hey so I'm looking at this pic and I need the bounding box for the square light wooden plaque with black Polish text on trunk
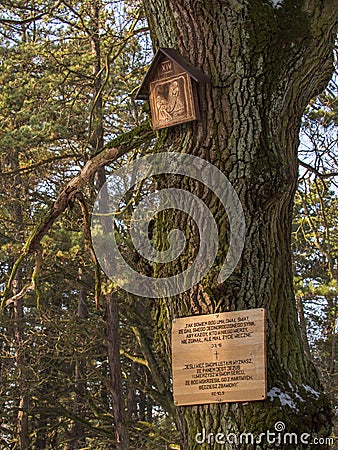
[172,309,266,406]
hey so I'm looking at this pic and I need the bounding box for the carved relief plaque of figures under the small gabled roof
[150,73,198,130]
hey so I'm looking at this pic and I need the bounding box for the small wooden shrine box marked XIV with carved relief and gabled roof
[135,48,211,130]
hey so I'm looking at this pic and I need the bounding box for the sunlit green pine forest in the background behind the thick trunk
[0,0,338,450]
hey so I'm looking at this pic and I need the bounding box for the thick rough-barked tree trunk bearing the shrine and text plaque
[145,0,335,449]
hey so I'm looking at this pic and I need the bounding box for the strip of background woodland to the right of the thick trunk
[293,73,338,434]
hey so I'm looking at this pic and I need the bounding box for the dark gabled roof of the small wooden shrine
[135,47,211,100]
